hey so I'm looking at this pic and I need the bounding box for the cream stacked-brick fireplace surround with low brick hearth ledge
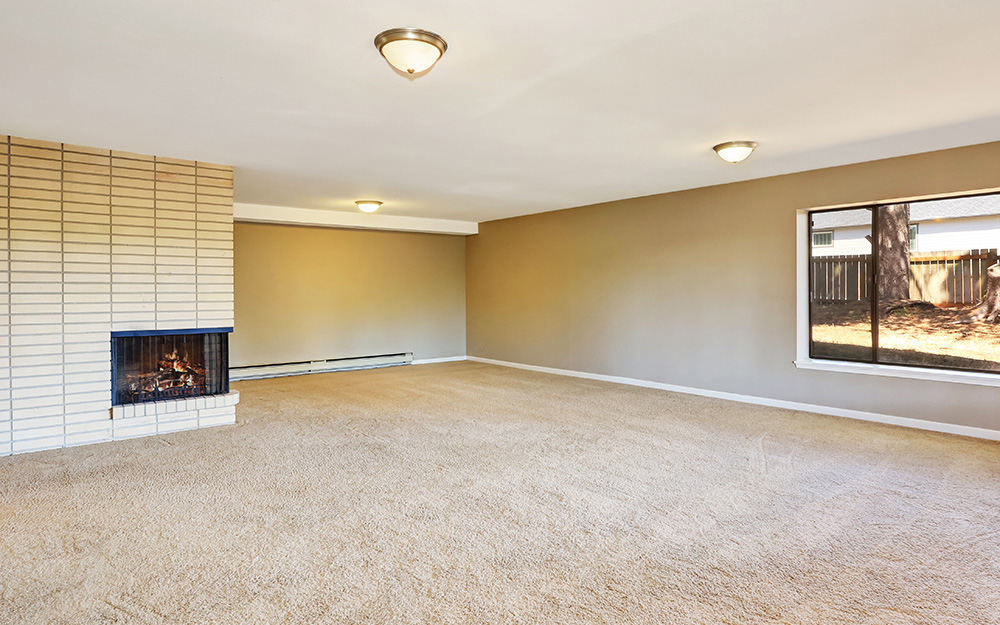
[0,135,239,455]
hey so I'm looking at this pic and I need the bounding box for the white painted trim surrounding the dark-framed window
[794,187,1000,387]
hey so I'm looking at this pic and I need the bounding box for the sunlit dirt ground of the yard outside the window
[812,303,1000,371]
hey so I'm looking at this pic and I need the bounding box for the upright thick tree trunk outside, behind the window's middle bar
[876,204,910,306]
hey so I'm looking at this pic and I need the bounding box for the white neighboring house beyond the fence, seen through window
[812,195,1000,256]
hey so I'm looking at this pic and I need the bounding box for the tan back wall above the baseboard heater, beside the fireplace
[231,223,465,366]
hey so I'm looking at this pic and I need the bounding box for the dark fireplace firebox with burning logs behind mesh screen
[111,328,233,406]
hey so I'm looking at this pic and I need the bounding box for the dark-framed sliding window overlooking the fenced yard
[806,194,1000,373]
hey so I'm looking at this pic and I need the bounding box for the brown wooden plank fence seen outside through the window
[812,249,998,307]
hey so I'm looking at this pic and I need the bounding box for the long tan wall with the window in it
[466,143,1000,429]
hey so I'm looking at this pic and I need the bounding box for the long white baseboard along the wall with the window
[467,356,1000,441]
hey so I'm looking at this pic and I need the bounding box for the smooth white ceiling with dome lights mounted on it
[0,0,1000,221]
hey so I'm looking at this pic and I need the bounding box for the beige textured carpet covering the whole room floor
[0,363,1000,625]
